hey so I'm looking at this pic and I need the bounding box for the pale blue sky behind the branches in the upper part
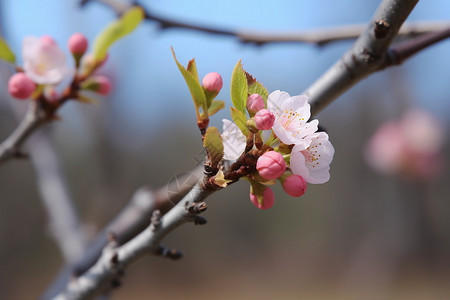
[0,0,450,134]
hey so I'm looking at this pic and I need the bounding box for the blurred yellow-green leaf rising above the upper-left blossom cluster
[93,6,144,62]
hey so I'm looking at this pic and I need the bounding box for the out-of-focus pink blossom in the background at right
[364,109,445,180]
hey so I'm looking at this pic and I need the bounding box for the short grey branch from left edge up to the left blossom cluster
[0,101,49,165]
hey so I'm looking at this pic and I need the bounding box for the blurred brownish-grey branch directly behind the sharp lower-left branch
[42,165,203,299]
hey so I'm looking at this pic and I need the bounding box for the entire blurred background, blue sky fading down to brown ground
[0,0,450,299]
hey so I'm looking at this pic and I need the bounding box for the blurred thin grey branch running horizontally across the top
[80,0,450,46]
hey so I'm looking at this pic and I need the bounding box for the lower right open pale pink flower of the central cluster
[290,132,334,184]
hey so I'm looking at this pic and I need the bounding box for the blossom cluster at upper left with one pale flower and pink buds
[8,33,111,105]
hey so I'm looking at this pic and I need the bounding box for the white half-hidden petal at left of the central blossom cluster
[222,119,247,160]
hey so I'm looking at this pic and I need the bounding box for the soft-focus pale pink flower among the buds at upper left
[22,36,72,84]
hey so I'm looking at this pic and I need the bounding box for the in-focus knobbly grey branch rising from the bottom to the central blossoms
[54,179,214,300]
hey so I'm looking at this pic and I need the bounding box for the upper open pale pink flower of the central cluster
[267,90,319,148]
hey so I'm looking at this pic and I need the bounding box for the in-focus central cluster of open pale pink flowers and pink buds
[222,90,334,209]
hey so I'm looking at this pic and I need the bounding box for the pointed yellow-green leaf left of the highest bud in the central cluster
[172,48,208,116]
